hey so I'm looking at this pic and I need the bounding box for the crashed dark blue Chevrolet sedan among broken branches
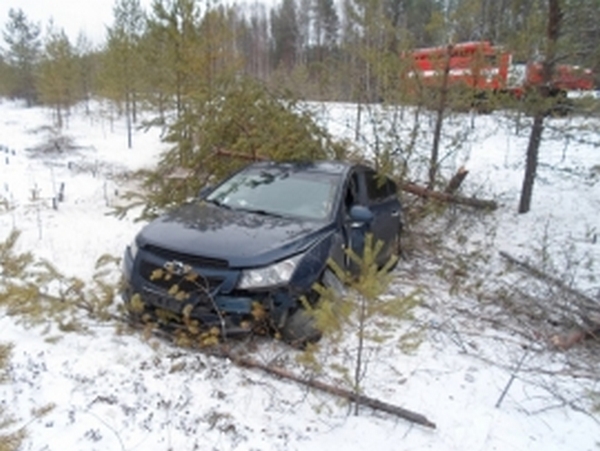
[124,161,402,344]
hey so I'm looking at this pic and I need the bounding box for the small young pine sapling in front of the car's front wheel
[299,234,421,414]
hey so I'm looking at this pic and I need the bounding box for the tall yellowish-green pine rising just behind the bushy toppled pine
[143,0,243,152]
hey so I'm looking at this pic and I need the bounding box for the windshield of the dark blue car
[206,168,337,220]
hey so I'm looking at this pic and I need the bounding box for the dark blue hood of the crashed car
[138,202,334,267]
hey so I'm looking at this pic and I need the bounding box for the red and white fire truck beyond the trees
[404,41,594,97]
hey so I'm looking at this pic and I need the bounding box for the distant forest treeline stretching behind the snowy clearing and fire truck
[0,0,600,121]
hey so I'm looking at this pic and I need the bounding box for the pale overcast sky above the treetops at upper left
[0,0,152,44]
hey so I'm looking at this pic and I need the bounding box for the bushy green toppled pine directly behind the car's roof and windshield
[116,78,343,222]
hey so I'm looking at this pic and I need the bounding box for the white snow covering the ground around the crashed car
[0,100,600,451]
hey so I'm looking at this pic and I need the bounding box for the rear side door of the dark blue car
[363,169,401,265]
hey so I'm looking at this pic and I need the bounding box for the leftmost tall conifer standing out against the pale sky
[3,8,41,106]
